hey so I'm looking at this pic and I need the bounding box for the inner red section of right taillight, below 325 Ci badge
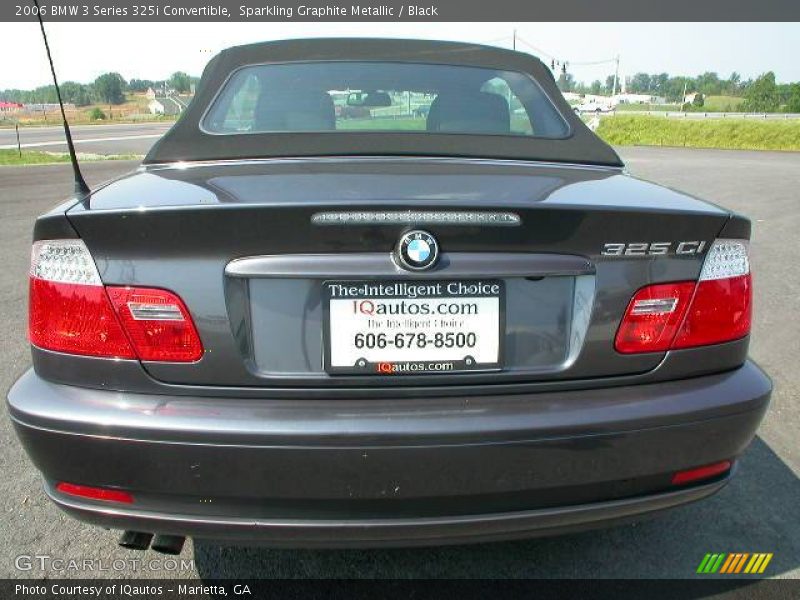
[614,281,695,354]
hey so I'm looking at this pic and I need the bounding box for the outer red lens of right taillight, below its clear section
[672,274,753,348]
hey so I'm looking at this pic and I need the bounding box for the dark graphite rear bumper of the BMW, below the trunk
[8,362,771,546]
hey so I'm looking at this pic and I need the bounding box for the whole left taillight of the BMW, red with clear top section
[28,240,203,362]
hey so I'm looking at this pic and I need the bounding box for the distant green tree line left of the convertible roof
[0,71,198,106]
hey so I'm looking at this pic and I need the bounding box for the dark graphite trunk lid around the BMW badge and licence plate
[68,158,729,387]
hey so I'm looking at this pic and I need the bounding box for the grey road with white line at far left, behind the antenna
[0,122,172,154]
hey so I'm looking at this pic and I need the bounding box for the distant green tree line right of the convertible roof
[558,71,800,113]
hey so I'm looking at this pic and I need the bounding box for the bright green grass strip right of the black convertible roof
[596,115,800,151]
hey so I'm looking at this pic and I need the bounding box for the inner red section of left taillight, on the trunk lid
[106,287,203,362]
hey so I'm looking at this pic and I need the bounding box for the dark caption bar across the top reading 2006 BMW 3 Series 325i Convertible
[0,0,800,22]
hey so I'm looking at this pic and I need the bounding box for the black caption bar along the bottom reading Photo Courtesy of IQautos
[6,579,800,600]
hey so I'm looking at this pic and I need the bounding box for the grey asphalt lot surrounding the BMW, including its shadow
[0,148,800,578]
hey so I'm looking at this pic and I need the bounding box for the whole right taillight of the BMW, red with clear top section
[614,240,753,354]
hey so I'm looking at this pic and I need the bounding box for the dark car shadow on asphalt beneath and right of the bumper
[194,438,800,579]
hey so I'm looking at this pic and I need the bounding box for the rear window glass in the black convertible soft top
[202,61,569,138]
